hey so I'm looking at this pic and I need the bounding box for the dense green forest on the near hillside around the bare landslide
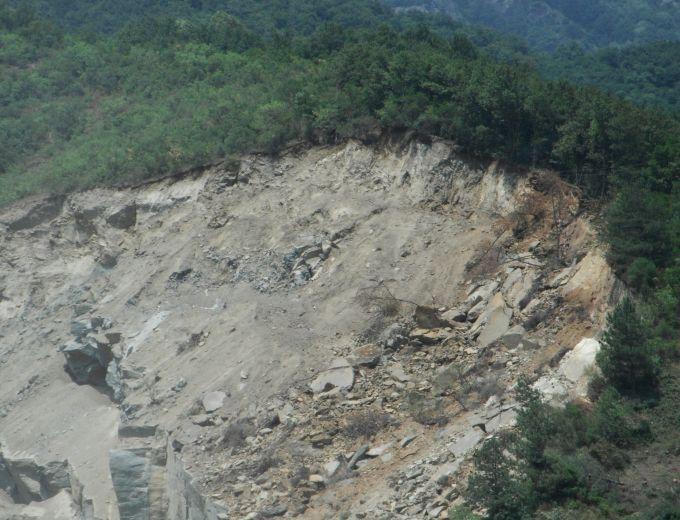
[0,0,680,519]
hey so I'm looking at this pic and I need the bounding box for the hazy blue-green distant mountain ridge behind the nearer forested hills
[388,0,680,50]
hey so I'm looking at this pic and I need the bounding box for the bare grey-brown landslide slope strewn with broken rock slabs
[0,136,617,520]
